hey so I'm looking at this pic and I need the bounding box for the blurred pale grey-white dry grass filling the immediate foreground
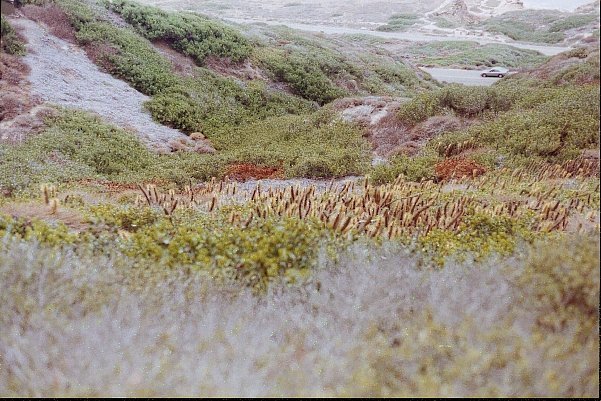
[0,238,599,397]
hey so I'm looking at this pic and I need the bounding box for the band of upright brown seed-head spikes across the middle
[158,164,598,239]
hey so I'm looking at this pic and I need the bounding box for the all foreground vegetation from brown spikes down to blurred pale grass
[0,167,599,396]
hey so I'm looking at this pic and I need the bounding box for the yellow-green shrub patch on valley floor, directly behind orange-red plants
[212,111,369,178]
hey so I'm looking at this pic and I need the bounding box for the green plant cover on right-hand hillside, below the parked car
[372,55,599,181]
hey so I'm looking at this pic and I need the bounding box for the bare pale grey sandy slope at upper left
[11,18,193,152]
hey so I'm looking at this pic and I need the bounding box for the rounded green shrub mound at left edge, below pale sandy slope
[0,111,153,190]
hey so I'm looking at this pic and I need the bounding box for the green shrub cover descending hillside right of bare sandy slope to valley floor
[12,0,432,173]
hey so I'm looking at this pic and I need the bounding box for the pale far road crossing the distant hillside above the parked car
[224,18,571,56]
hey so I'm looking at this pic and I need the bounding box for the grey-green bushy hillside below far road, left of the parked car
[253,27,426,104]
